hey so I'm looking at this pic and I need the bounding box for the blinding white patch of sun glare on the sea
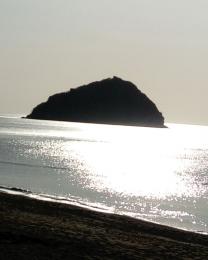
[61,124,205,198]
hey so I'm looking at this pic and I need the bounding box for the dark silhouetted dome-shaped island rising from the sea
[27,77,164,127]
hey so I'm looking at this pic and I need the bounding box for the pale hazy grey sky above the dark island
[0,0,208,125]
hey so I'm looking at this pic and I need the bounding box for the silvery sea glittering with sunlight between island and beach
[0,117,208,233]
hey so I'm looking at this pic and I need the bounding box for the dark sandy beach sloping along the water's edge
[0,192,208,260]
